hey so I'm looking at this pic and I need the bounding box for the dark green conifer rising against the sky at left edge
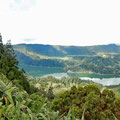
[0,34,30,92]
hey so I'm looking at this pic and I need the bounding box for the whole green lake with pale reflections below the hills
[20,66,120,86]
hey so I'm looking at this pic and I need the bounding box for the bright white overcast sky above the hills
[0,0,120,46]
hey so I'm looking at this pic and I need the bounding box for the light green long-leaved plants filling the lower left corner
[0,74,58,120]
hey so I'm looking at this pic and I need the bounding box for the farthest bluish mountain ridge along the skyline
[14,44,120,57]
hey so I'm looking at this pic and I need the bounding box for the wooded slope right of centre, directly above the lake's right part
[67,55,120,75]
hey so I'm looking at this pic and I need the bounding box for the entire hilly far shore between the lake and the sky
[14,44,120,75]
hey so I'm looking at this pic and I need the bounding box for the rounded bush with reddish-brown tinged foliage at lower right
[52,84,120,120]
